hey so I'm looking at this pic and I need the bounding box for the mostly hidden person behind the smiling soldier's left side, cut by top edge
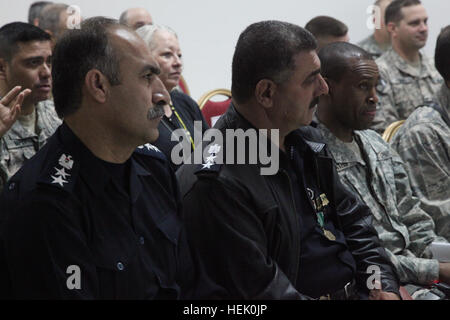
[358,0,392,59]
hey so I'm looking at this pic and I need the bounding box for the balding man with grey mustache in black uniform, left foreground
[0,17,197,299]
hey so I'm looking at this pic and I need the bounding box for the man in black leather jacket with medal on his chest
[178,21,399,299]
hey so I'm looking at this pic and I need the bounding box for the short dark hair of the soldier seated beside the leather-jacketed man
[319,42,373,82]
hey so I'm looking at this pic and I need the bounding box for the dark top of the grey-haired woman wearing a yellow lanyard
[153,90,209,170]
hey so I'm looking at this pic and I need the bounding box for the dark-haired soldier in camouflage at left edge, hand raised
[0,22,61,191]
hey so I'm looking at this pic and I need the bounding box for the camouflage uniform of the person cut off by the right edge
[391,84,450,241]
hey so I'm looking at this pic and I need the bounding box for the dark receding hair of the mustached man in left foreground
[52,17,125,118]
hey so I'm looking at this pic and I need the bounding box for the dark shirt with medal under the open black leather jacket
[281,136,356,298]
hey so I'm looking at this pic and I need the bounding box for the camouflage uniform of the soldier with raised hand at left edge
[0,100,61,191]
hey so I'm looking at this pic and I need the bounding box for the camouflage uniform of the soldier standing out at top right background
[372,49,443,133]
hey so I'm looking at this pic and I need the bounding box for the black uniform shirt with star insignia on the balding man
[0,124,193,299]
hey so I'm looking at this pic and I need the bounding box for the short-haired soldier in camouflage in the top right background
[372,0,442,133]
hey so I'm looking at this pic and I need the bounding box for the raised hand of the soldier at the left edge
[0,86,31,137]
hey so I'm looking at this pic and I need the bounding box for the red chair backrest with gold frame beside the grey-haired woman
[198,89,231,127]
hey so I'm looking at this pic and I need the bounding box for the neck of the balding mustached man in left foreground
[64,108,138,163]
